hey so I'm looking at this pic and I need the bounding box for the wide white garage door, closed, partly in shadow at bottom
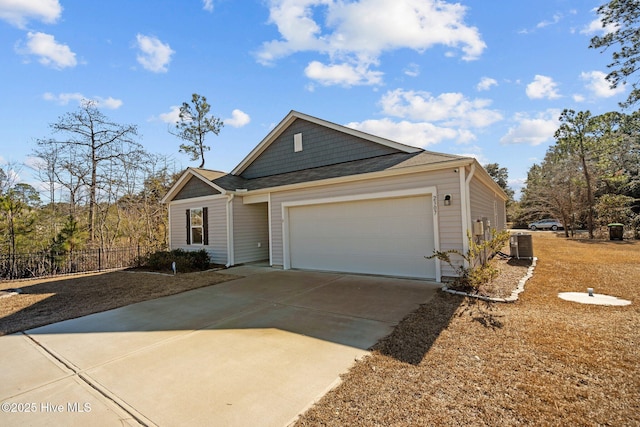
[289,196,436,278]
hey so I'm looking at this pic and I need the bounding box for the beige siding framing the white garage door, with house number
[271,168,462,273]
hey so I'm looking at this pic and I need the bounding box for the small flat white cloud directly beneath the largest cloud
[304,61,383,86]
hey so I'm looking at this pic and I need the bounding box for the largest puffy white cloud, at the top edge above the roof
[257,0,486,84]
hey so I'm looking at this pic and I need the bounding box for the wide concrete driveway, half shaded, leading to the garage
[0,267,438,426]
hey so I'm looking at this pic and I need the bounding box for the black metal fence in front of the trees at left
[0,246,164,280]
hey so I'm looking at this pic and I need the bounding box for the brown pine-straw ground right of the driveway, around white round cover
[297,232,640,426]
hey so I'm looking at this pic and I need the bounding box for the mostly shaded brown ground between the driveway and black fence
[0,271,238,336]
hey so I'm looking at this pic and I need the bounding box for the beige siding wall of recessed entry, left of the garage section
[233,197,269,264]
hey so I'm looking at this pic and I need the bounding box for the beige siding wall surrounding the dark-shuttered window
[169,197,227,264]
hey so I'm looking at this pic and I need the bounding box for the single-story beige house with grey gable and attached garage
[163,111,507,281]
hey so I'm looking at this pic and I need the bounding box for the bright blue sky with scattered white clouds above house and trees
[0,0,628,199]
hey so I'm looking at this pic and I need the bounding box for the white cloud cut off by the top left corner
[0,0,62,28]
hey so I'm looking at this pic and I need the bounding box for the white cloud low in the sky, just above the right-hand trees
[500,109,560,146]
